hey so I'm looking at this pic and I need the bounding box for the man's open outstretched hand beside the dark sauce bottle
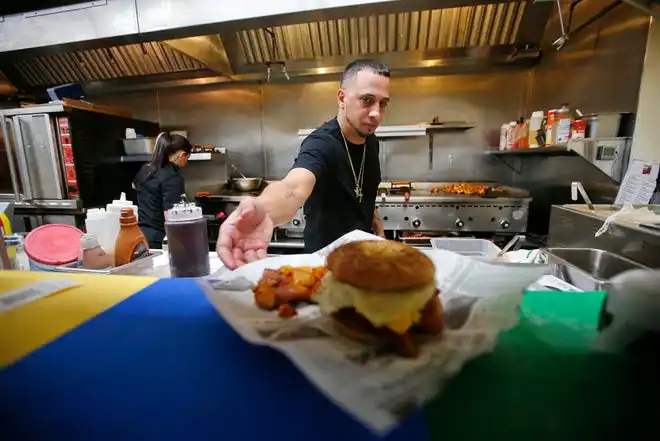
[216,198,274,270]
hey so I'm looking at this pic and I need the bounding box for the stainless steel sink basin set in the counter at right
[545,248,648,291]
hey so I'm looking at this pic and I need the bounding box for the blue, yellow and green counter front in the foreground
[0,271,660,441]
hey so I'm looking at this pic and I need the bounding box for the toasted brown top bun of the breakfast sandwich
[327,240,435,291]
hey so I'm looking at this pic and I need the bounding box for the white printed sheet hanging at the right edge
[615,159,660,205]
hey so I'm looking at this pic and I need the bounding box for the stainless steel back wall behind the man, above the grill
[93,71,527,180]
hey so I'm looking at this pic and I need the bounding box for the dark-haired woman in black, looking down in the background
[133,132,192,248]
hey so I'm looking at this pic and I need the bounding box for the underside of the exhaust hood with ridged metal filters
[1,1,553,90]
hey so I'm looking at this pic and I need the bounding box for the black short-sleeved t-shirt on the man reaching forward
[293,118,380,253]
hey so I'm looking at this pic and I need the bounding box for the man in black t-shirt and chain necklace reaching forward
[217,60,390,269]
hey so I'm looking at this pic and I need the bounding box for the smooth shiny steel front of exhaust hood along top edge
[0,0,490,52]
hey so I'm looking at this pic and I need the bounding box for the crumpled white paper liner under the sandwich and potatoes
[200,231,549,433]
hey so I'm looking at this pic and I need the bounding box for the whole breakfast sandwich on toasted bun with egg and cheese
[312,240,444,357]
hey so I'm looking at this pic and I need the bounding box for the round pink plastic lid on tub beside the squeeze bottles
[25,224,83,266]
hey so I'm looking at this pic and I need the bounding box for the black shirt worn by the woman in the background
[133,163,185,243]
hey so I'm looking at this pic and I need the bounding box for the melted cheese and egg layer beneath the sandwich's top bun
[313,273,435,334]
